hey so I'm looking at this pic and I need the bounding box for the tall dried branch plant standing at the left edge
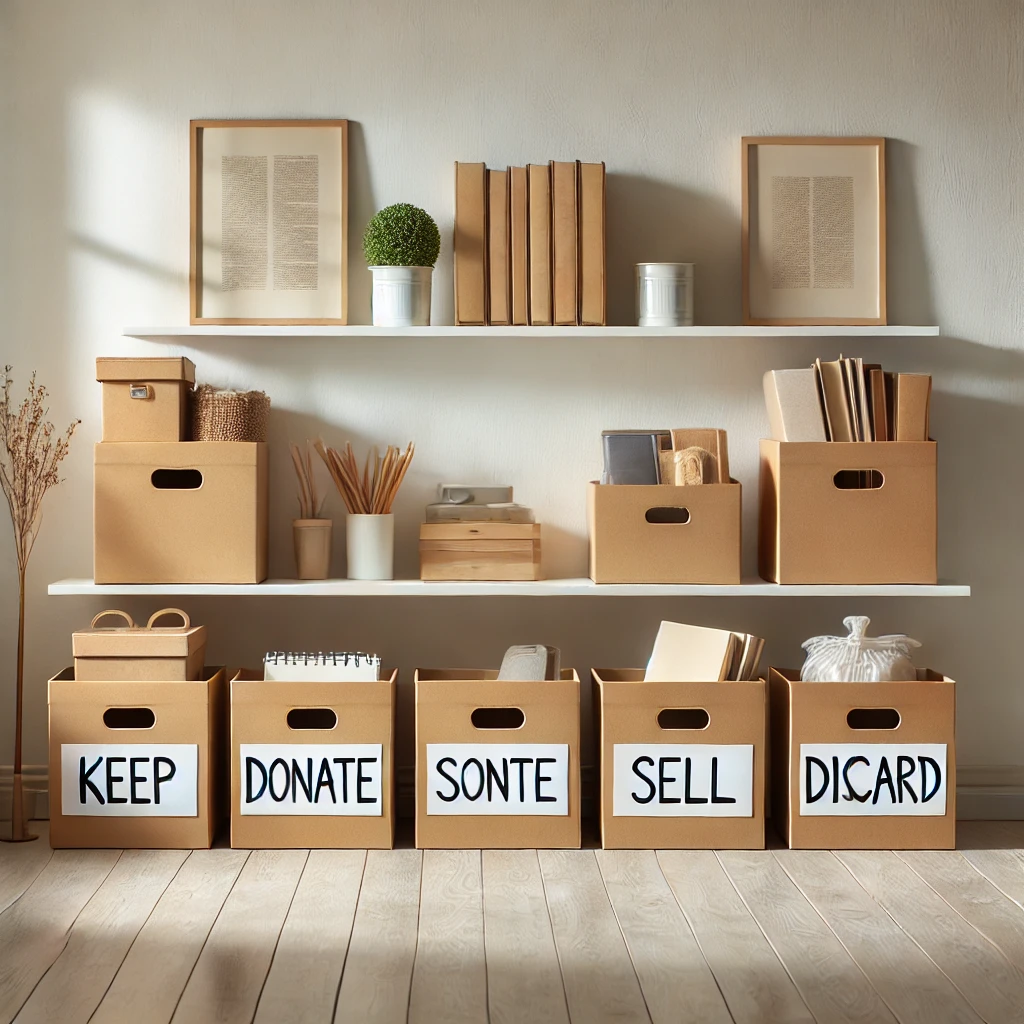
[0,366,81,840]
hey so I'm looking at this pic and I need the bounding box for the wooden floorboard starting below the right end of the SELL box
[718,852,895,1024]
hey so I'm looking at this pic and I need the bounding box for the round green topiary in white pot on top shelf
[362,203,441,327]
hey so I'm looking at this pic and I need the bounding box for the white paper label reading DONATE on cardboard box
[239,743,384,817]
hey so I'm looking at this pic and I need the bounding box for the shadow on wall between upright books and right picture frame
[606,172,740,324]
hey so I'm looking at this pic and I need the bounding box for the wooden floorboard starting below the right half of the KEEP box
[15,850,187,1024]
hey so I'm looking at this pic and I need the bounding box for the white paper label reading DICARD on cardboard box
[800,743,946,817]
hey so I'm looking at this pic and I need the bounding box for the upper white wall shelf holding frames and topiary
[121,324,939,340]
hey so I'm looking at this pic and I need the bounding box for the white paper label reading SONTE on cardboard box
[427,743,569,815]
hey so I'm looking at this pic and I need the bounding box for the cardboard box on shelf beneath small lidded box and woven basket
[93,441,267,584]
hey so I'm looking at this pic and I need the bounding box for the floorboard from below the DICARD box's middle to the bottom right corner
[836,851,1024,1024]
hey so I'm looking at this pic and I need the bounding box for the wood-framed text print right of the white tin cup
[742,136,886,327]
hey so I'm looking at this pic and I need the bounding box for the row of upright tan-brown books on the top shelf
[455,161,606,326]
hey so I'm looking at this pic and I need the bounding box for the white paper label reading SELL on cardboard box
[611,743,754,818]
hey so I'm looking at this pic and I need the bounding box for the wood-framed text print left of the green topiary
[188,121,348,325]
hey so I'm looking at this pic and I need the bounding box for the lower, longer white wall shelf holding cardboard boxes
[49,578,971,597]
